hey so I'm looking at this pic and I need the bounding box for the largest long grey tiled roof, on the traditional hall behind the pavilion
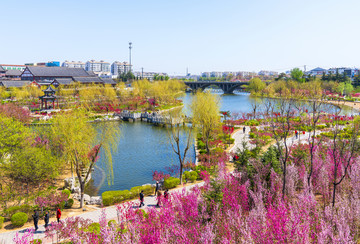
[27,66,89,77]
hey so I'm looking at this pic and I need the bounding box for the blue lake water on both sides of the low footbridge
[86,90,351,195]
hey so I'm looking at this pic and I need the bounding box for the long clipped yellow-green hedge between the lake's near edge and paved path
[101,185,154,206]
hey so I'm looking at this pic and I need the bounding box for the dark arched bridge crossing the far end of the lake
[185,81,249,94]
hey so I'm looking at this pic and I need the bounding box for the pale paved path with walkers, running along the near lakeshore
[0,182,204,244]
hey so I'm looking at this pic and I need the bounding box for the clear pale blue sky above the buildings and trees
[0,0,360,75]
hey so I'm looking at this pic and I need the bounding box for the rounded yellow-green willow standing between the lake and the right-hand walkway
[190,91,220,155]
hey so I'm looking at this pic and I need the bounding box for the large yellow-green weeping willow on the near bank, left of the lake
[51,109,120,208]
